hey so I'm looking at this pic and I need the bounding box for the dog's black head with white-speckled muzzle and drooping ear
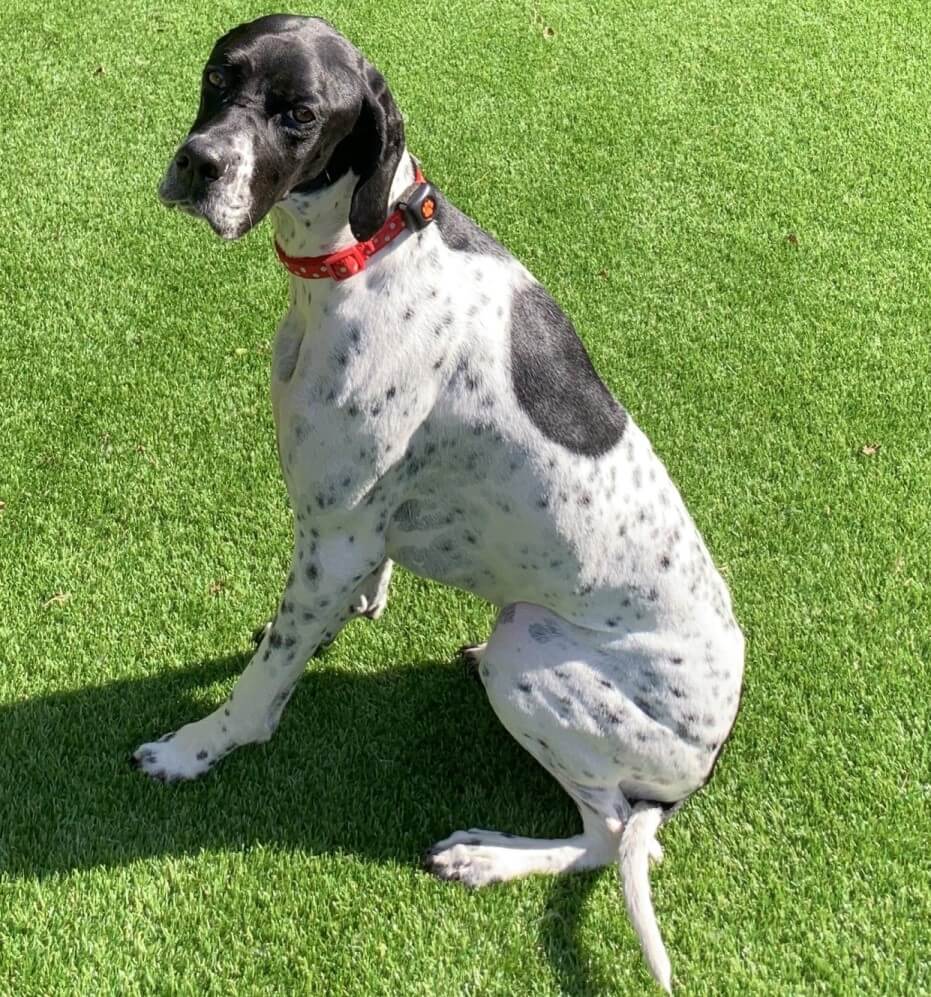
[159,15,404,239]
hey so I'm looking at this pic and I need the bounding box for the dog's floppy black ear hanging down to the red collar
[349,66,404,240]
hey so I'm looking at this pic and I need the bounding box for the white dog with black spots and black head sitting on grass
[133,15,744,989]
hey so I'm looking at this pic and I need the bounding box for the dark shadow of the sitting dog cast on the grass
[0,655,620,993]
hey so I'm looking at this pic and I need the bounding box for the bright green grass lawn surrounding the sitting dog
[0,0,931,997]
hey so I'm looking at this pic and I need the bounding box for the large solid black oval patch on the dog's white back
[511,284,627,457]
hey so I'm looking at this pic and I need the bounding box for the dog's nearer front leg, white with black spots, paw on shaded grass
[132,517,385,781]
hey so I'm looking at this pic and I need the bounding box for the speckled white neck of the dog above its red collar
[271,151,414,258]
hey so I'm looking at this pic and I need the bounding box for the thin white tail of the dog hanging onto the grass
[618,803,672,993]
